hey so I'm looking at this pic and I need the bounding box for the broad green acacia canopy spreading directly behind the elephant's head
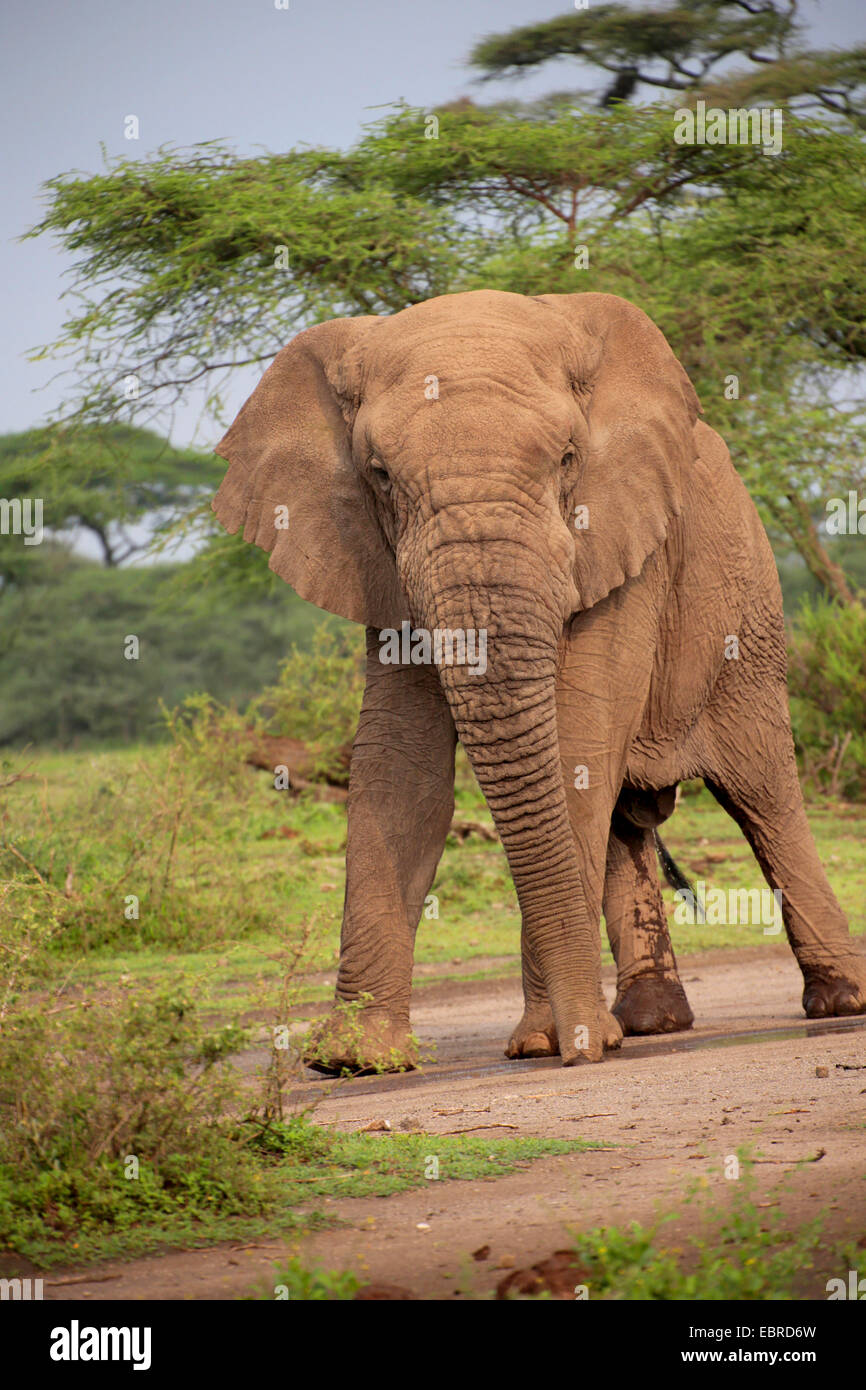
[25,0,866,600]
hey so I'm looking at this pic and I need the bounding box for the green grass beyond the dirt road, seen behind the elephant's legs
[0,748,866,1009]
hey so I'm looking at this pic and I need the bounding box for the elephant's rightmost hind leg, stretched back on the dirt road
[705,694,866,1019]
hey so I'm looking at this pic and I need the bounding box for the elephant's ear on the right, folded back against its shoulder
[538,295,701,609]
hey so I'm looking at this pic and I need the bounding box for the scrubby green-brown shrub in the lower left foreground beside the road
[0,884,325,1258]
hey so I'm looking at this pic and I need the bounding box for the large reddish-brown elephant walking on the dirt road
[213,291,866,1072]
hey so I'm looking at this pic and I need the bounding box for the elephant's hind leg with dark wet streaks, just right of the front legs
[605,813,694,1036]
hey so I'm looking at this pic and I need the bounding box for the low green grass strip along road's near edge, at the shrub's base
[0,1116,598,1269]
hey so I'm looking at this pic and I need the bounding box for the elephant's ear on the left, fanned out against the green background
[211,318,409,628]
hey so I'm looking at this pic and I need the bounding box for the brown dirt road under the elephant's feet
[40,948,866,1301]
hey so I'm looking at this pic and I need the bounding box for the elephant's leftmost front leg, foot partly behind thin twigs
[304,630,456,1073]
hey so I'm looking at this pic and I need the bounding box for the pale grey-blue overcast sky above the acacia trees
[0,0,866,448]
